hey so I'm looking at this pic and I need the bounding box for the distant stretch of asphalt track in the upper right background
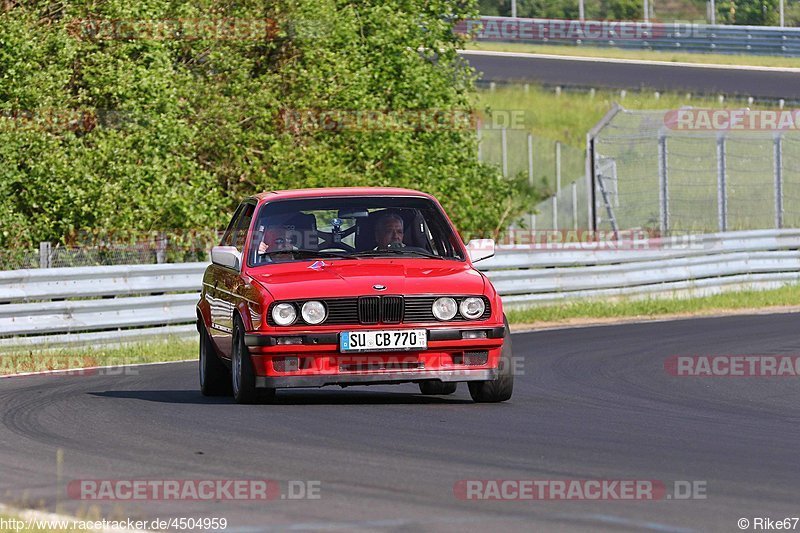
[462,51,800,100]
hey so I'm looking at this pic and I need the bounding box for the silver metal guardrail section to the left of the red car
[0,263,208,350]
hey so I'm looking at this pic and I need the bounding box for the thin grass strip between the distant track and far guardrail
[467,42,798,68]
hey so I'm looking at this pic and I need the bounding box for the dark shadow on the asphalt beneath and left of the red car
[89,390,473,405]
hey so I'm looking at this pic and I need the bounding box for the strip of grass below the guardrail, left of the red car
[0,338,197,375]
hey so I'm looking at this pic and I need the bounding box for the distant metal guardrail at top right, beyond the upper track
[456,17,800,57]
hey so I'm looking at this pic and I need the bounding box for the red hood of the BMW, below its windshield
[250,259,484,300]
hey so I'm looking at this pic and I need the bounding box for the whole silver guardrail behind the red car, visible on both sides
[0,230,800,344]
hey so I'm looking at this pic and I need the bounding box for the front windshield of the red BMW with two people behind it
[248,196,464,266]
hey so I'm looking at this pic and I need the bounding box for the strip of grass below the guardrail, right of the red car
[507,285,800,324]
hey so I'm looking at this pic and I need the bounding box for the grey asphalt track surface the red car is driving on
[0,314,800,533]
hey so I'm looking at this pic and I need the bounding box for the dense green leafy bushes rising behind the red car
[0,0,527,247]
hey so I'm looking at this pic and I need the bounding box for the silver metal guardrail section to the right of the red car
[481,229,800,308]
